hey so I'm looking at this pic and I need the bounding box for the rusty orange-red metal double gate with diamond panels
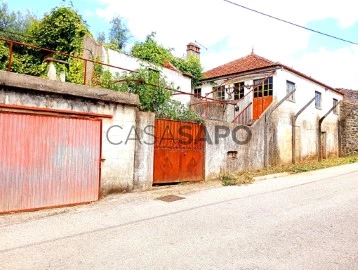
[153,119,205,184]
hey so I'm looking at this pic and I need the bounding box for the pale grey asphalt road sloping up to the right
[0,163,358,270]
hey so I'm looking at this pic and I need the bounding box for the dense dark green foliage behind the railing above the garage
[0,3,91,83]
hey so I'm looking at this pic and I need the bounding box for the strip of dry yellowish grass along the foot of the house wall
[219,155,358,186]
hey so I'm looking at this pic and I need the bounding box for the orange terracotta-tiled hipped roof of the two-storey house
[204,53,276,79]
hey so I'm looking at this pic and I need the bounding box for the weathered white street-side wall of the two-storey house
[273,69,343,163]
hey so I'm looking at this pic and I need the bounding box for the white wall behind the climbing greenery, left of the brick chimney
[102,48,191,105]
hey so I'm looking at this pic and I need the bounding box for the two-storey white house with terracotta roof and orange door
[196,53,343,164]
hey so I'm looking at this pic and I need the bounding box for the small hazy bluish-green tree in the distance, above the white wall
[109,16,130,51]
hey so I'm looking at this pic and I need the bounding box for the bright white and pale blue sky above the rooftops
[5,0,358,89]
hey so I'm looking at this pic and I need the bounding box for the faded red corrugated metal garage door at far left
[0,112,101,213]
